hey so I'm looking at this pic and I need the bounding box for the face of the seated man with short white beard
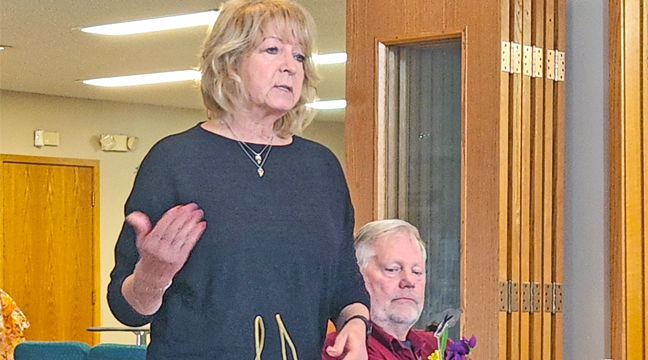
[362,231,425,327]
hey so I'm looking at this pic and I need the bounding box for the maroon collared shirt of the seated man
[322,323,438,360]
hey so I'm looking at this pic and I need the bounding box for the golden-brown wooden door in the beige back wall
[0,155,99,345]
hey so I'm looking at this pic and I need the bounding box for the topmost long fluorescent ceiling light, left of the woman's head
[81,10,219,35]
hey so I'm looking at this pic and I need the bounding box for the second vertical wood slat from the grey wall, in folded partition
[542,0,555,360]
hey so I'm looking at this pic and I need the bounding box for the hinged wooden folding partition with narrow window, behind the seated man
[345,0,565,360]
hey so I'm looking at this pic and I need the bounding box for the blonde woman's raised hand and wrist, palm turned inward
[126,203,207,288]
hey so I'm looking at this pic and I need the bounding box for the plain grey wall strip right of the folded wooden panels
[563,0,610,360]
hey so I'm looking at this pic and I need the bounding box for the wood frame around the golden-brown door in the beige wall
[0,154,101,344]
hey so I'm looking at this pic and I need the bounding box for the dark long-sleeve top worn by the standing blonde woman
[108,125,368,360]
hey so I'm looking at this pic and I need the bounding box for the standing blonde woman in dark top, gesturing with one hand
[108,0,369,360]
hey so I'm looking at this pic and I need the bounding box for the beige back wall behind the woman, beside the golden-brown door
[0,90,344,344]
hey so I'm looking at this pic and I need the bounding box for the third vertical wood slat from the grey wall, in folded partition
[530,0,544,360]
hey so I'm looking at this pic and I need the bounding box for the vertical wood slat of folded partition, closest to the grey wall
[553,0,567,359]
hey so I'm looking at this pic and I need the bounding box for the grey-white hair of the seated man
[354,219,427,270]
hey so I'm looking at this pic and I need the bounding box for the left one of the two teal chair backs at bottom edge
[14,341,90,360]
